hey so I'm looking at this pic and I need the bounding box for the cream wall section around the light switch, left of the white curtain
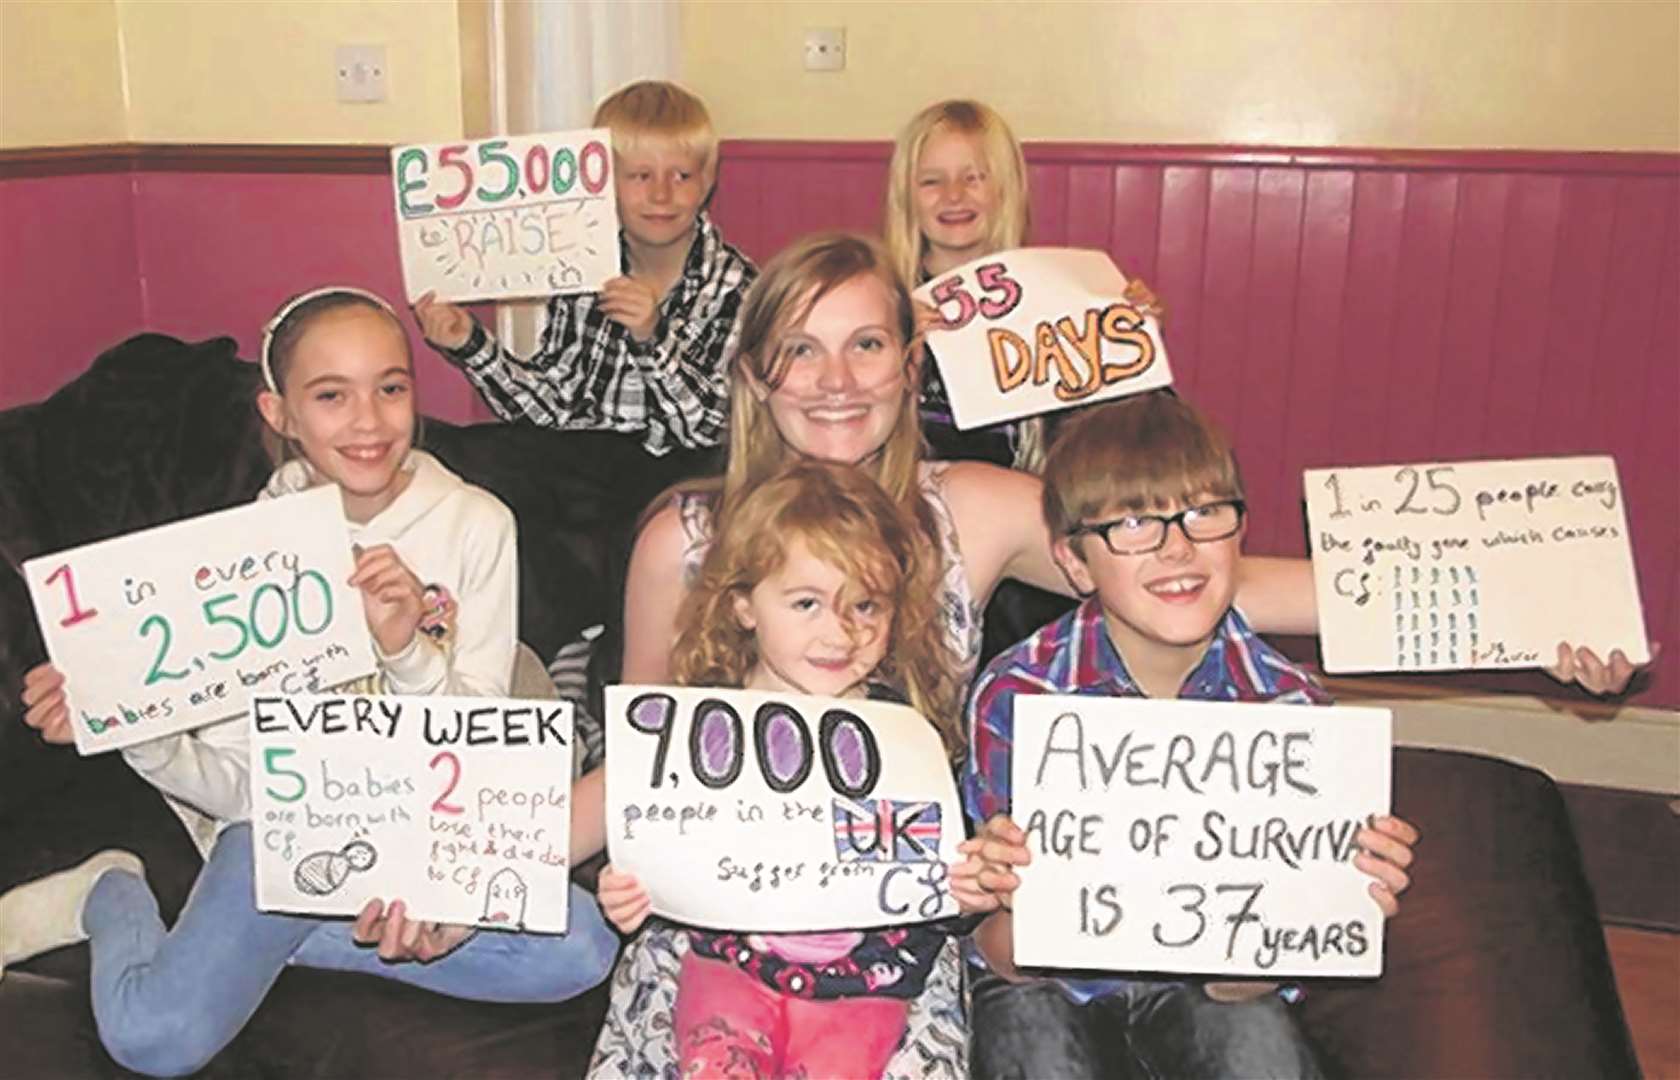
[116,0,460,143]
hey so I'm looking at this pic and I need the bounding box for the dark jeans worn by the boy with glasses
[969,971,1324,1080]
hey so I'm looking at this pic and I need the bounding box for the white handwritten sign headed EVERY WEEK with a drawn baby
[250,695,571,934]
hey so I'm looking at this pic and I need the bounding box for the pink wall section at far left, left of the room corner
[0,173,144,408]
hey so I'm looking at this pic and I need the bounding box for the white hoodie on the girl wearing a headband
[123,450,519,823]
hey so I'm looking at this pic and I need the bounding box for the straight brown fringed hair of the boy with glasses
[1043,390,1243,537]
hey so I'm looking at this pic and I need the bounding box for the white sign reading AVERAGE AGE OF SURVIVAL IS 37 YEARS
[1011,695,1391,978]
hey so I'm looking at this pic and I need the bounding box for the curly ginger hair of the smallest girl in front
[670,459,963,758]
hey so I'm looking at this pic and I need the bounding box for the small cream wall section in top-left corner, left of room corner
[0,0,128,148]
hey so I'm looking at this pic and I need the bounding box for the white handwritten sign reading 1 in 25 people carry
[1305,457,1650,672]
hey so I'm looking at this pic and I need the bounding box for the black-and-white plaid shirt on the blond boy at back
[445,213,758,455]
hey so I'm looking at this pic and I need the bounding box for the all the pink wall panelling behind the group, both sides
[0,141,1680,705]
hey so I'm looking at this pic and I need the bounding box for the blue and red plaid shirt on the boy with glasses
[961,596,1331,1003]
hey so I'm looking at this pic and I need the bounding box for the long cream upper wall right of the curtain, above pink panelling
[682,0,1680,151]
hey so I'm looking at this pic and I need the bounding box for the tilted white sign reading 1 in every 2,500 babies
[24,485,375,754]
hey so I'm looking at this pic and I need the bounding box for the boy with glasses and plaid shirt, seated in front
[963,391,1418,1078]
